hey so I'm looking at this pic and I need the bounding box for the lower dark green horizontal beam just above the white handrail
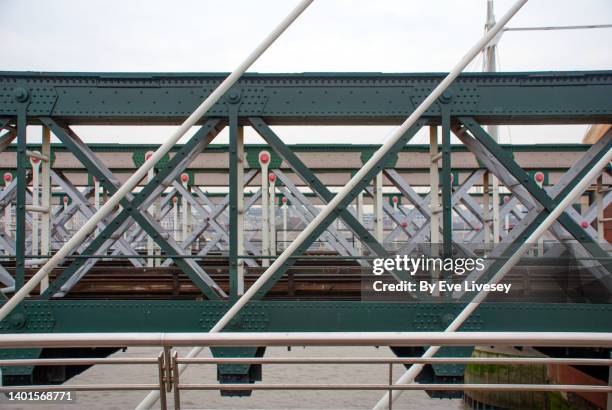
[0,300,612,333]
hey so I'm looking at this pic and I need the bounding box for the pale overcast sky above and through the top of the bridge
[0,0,612,143]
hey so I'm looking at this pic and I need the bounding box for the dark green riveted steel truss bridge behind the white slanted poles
[0,71,612,394]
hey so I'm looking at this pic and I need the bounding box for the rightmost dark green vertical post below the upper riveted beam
[441,105,453,257]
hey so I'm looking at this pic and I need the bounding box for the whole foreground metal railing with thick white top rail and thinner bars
[0,332,612,409]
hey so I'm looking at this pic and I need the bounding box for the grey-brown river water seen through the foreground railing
[0,347,463,410]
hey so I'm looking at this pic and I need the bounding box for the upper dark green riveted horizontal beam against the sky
[0,71,612,124]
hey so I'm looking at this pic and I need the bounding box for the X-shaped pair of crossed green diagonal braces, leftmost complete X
[42,119,224,299]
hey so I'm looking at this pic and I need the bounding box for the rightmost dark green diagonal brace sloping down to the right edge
[459,117,612,273]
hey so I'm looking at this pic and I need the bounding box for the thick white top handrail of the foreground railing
[0,332,612,348]
